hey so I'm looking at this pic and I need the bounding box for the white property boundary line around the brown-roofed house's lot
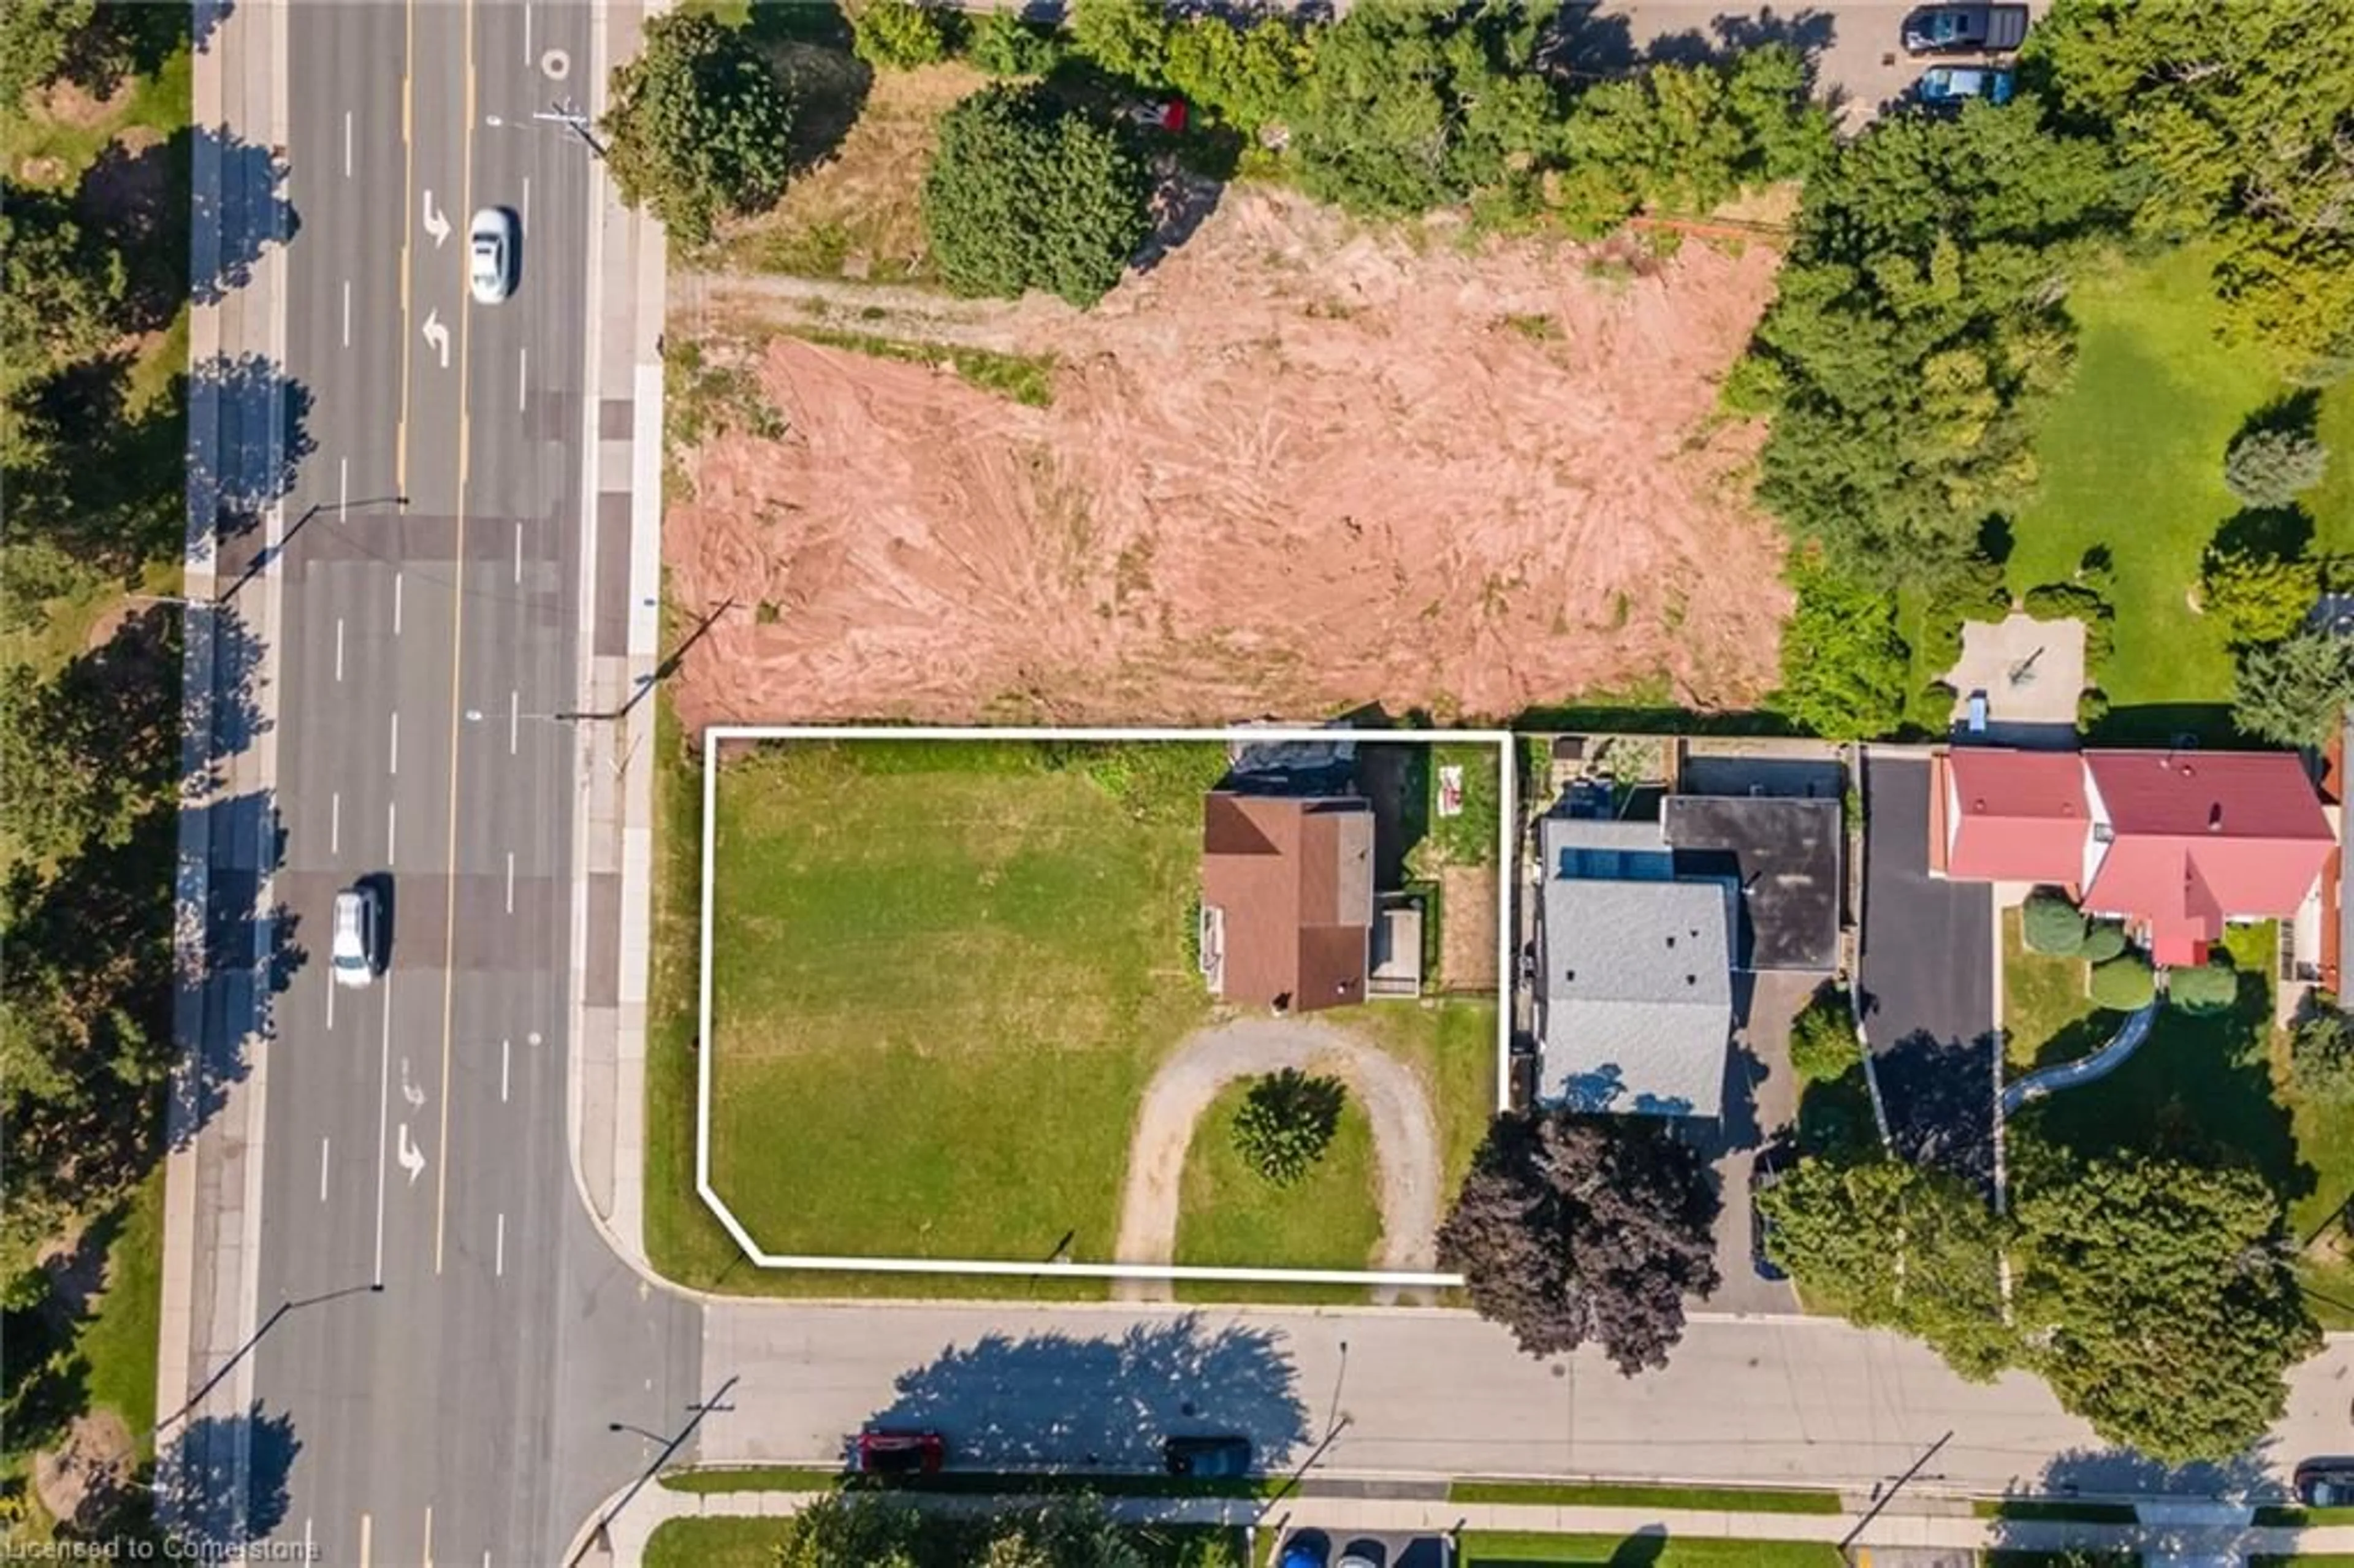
[695,725,1521,1285]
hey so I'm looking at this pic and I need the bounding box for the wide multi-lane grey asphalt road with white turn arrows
[252,0,697,1563]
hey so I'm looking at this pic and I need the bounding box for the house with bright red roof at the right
[1930,747,2337,965]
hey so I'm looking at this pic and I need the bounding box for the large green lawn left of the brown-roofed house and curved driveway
[709,744,1222,1260]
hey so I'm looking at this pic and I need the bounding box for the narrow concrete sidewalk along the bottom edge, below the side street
[593,1486,2354,1568]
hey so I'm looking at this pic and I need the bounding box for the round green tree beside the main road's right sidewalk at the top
[605,12,793,245]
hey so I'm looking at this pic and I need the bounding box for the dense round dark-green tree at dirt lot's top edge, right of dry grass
[923,82,1151,308]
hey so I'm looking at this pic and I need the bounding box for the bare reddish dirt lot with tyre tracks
[664,186,1787,728]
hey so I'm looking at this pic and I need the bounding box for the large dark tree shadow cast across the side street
[845,1314,1309,1472]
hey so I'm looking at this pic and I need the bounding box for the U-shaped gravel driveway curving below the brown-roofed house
[1113,1019,1438,1300]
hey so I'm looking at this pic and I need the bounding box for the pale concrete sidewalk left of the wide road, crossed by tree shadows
[155,5,287,1540]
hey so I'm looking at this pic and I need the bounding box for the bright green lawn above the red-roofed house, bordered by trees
[2010,249,2354,734]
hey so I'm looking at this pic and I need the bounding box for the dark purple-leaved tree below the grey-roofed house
[1438,1111,1718,1377]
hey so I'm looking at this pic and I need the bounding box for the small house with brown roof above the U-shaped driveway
[1200,789,1375,1013]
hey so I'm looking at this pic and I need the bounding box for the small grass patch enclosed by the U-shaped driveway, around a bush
[1177,1083,1382,1269]
